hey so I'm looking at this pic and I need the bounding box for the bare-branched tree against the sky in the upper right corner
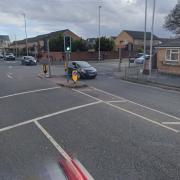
[163,3,180,34]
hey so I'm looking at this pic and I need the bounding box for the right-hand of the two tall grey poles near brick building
[149,0,156,76]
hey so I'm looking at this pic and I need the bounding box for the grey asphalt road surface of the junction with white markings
[0,61,180,180]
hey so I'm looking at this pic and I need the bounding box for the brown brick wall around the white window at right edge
[157,48,180,75]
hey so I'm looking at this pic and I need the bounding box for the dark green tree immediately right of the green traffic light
[71,39,87,52]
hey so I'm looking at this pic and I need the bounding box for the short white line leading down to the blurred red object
[34,121,71,160]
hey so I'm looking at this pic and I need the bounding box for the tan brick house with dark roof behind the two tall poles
[115,30,160,51]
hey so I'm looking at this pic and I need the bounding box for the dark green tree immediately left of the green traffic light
[49,33,64,52]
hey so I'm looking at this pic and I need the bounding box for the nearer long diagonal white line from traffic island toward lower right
[73,89,179,133]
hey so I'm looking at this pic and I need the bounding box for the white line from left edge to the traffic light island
[0,86,61,99]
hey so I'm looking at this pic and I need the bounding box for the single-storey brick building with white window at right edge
[156,39,180,75]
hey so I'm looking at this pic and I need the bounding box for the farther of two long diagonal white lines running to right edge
[92,87,180,121]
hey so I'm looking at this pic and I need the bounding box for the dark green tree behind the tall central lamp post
[95,37,114,51]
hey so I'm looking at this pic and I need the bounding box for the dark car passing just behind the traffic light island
[68,61,97,78]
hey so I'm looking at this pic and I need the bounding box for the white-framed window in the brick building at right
[166,49,179,62]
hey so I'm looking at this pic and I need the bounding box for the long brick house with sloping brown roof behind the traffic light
[10,29,81,52]
